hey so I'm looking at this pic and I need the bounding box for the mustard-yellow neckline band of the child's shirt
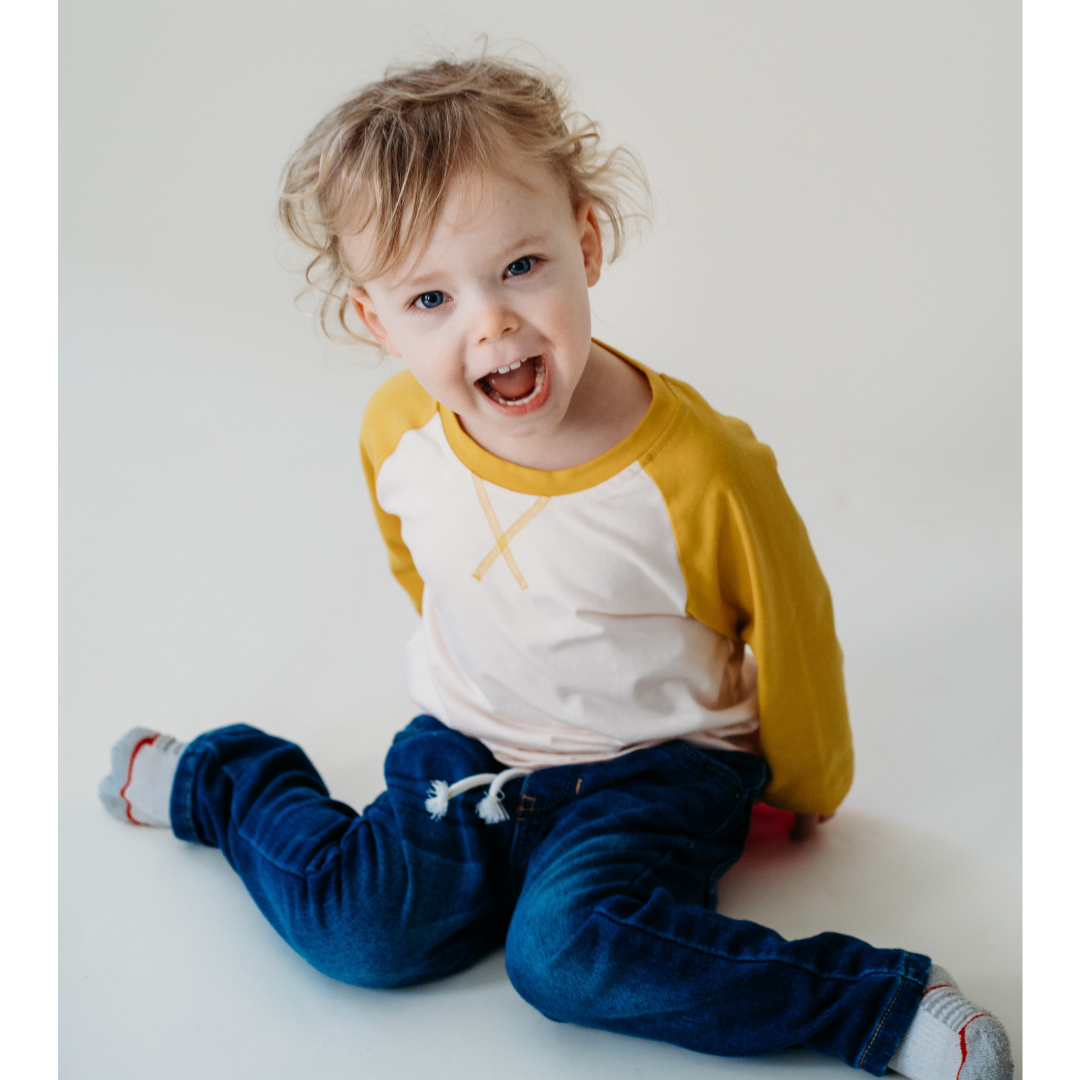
[438,338,679,496]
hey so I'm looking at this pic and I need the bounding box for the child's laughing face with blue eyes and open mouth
[345,157,603,446]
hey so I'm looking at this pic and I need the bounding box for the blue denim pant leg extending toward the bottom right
[507,742,930,1076]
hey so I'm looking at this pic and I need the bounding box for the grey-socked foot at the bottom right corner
[889,963,1012,1080]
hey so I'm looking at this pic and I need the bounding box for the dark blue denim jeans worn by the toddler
[172,716,930,1076]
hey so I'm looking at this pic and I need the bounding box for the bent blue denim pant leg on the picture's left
[172,717,512,987]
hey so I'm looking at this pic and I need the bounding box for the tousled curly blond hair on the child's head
[278,55,651,343]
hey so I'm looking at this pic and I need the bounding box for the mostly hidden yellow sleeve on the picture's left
[360,372,438,611]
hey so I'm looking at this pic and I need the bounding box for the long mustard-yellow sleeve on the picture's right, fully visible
[642,379,854,813]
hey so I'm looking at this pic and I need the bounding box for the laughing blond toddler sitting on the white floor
[100,56,1012,1080]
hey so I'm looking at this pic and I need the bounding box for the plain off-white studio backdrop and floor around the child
[58,0,1022,1080]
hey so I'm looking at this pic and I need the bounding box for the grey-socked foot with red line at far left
[97,728,187,828]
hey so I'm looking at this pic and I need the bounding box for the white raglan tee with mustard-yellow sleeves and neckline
[361,346,853,813]
